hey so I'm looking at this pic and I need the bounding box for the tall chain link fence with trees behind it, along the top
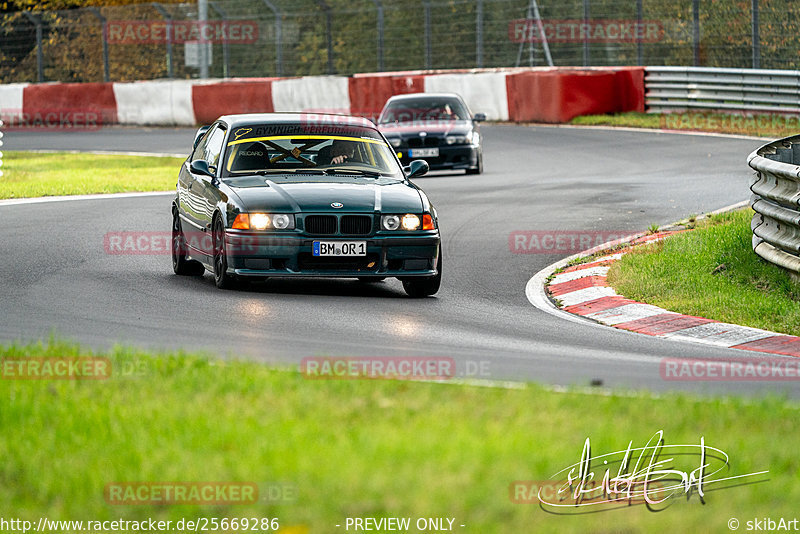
[0,0,800,83]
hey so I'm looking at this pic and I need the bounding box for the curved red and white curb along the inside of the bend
[526,232,800,357]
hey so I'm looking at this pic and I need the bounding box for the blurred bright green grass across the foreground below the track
[0,341,800,533]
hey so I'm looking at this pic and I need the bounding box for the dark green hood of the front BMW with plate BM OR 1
[227,179,422,213]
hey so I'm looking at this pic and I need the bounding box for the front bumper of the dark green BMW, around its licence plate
[225,230,440,278]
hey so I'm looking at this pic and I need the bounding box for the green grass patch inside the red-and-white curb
[608,209,800,335]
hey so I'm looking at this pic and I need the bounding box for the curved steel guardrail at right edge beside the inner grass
[747,135,800,278]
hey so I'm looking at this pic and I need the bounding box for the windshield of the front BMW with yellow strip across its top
[223,124,403,179]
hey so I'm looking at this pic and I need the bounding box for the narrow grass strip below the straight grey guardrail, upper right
[571,112,800,138]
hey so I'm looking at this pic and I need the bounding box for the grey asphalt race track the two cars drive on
[0,126,780,396]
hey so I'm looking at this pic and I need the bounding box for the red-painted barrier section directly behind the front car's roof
[192,78,274,124]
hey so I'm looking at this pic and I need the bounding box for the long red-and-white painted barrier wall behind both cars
[0,67,644,126]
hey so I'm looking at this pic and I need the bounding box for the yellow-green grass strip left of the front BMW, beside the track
[0,152,182,199]
